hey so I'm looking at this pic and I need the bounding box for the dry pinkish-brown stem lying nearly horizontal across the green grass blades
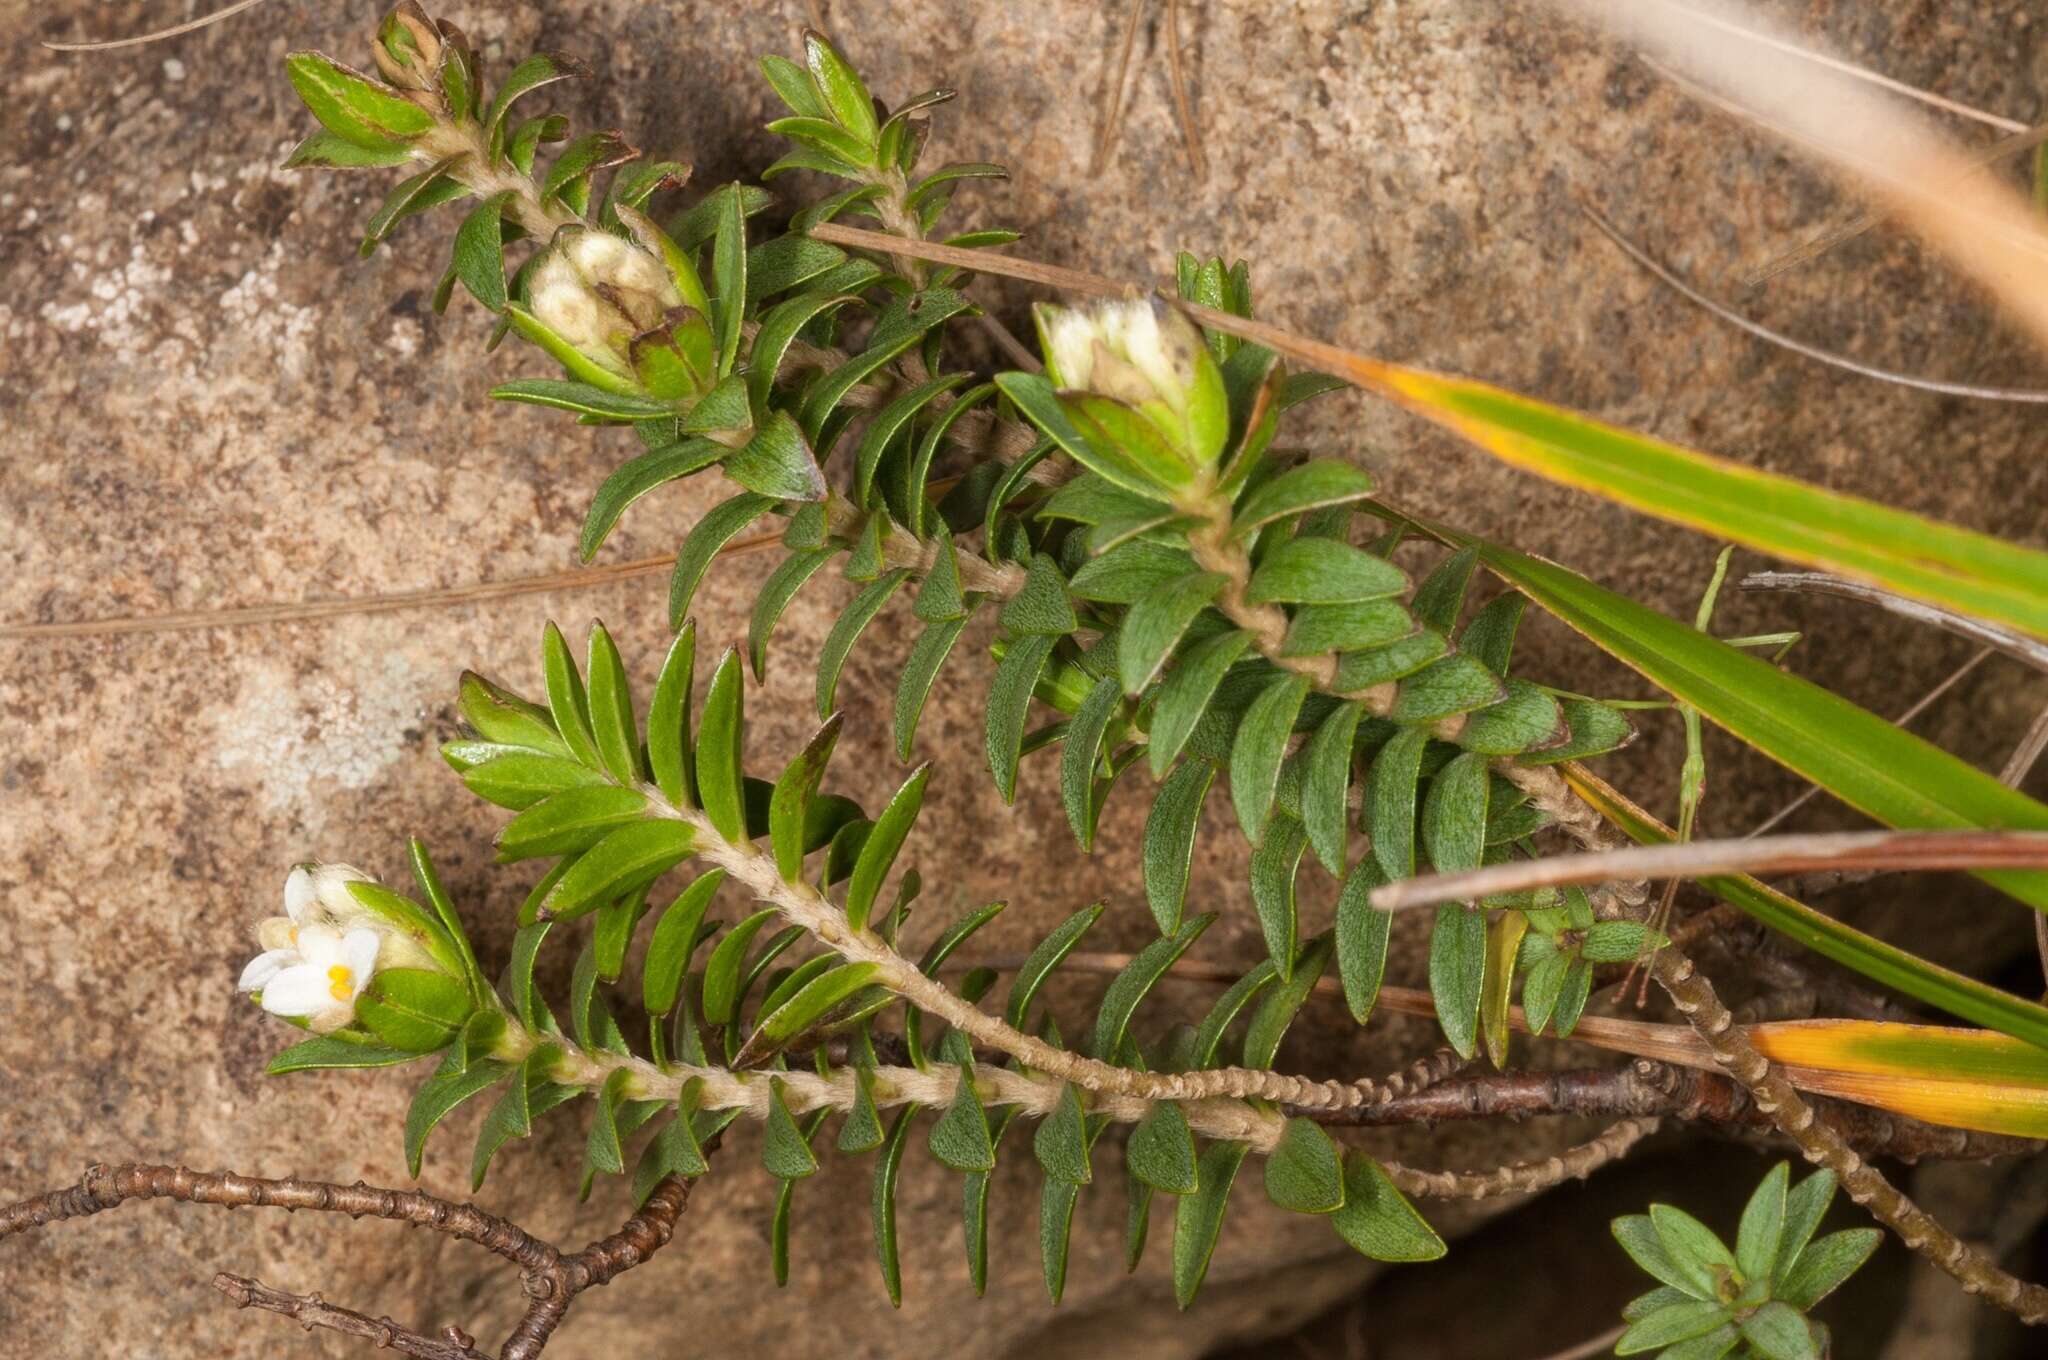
[1372,830,2048,911]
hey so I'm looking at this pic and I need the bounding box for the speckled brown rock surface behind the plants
[0,0,2048,1360]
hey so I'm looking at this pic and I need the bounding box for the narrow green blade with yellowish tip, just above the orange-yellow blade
[1561,762,2048,1053]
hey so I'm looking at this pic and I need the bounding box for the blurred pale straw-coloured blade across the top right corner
[1559,0,2048,344]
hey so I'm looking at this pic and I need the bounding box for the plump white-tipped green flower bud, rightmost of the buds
[1036,297,1231,490]
